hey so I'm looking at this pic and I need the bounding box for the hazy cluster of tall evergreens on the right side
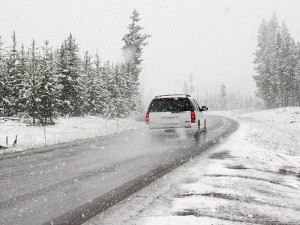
[254,14,300,108]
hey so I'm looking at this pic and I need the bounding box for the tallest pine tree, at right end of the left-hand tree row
[122,9,150,111]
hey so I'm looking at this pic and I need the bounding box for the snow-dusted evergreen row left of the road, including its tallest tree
[0,10,149,124]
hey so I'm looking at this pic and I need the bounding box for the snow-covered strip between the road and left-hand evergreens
[0,116,145,154]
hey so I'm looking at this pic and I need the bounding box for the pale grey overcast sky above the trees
[0,0,300,101]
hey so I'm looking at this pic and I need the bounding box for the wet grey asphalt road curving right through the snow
[0,116,237,225]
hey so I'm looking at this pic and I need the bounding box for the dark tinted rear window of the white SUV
[148,98,193,112]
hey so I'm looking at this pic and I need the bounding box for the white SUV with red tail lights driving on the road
[146,94,208,132]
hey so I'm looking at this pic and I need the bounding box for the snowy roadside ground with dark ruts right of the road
[86,107,300,225]
